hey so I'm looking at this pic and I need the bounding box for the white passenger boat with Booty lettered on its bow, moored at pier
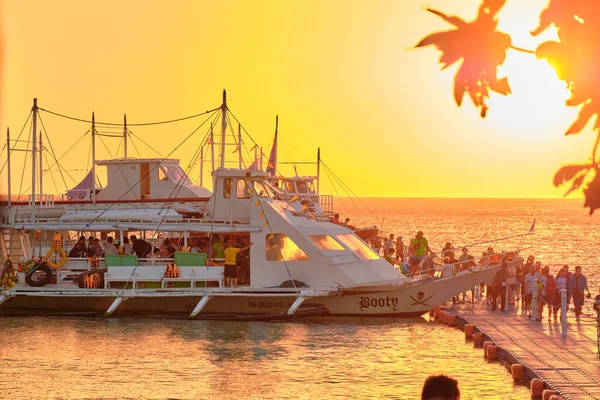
[0,94,522,319]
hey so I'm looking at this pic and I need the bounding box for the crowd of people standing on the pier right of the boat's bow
[486,256,591,321]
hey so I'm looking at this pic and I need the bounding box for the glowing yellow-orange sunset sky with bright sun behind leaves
[0,0,594,197]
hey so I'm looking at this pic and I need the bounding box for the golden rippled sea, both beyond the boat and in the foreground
[0,199,600,400]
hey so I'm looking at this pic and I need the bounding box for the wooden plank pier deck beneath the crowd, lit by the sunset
[450,298,600,400]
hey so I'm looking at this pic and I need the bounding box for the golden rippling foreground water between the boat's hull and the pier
[0,317,528,399]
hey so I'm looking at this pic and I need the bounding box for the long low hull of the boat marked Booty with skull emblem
[0,266,498,319]
